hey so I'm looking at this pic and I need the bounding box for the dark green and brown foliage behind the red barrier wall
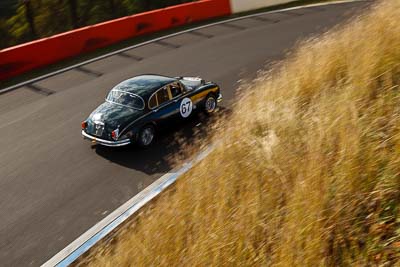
[0,0,193,48]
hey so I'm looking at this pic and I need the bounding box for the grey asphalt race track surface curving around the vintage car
[0,2,374,266]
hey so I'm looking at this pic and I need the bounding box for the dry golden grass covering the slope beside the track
[79,0,400,266]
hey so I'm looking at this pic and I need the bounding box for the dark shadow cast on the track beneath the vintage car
[94,107,229,175]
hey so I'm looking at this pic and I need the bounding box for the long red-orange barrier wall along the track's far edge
[0,0,231,80]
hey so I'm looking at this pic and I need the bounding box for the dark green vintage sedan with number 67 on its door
[82,74,222,147]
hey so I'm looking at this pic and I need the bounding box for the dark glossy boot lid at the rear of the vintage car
[89,102,144,132]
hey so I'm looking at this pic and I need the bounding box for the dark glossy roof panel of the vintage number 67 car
[113,74,177,99]
